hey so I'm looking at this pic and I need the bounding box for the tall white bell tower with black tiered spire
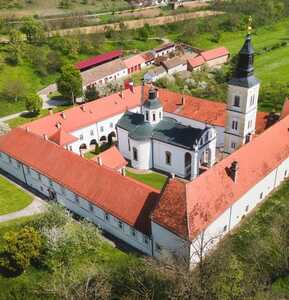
[224,18,260,154]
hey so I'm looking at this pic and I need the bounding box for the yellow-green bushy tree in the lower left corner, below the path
[0,227,41,274]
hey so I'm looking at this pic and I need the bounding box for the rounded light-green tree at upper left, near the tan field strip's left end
[20,17,45,43]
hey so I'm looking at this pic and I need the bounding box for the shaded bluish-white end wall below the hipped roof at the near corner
[151,221,190,261]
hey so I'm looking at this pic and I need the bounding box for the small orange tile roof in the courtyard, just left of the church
[93,146,127,171]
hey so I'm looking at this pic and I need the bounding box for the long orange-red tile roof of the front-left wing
[0,128,159,234]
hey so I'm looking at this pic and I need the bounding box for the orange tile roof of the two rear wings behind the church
[22,86,266,144]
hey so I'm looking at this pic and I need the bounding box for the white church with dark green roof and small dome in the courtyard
[116,89,216,179]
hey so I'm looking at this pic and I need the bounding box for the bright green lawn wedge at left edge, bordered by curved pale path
[0,177,32,215]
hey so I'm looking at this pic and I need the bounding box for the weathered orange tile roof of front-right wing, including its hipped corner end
[152,116,289,240]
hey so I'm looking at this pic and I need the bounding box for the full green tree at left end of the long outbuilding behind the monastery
[56,64,83,103]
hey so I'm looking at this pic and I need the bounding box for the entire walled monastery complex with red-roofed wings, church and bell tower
[0,35,289,266]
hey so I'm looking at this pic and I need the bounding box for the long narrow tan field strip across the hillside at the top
[50,10,222,36]
